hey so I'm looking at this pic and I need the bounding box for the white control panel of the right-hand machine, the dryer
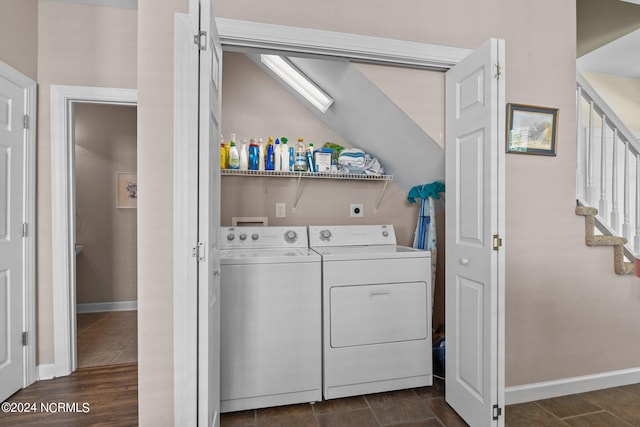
[309,224,397,247]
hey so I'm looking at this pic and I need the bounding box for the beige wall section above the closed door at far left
[0,0,38,80]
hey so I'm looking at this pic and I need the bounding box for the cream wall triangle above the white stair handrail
[584,73,640,133]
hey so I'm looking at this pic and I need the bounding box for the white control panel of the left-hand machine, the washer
[220,226,308,249]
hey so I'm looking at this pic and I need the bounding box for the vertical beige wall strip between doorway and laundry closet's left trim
[138,0,188,426]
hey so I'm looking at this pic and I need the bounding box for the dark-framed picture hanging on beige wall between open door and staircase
[507,104,558,156]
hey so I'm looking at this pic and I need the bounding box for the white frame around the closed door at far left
[0,61,38,387]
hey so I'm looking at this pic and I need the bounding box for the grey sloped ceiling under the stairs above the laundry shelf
[246,53,444,192]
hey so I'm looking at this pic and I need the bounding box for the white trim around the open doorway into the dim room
[51,85,138,378]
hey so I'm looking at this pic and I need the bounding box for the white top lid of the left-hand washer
[220,248,320,264]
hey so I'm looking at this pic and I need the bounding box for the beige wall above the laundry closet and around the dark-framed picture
[217,0,640,386]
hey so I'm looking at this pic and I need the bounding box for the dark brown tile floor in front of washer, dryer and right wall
[220,379,640,427]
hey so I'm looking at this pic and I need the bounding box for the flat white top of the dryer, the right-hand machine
[313,245,431,261]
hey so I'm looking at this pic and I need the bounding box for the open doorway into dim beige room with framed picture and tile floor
[73,103,137,368]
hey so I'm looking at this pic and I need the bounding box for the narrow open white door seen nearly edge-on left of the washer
[198,0,222,427]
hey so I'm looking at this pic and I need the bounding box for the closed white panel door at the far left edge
[0,67,26,401]
